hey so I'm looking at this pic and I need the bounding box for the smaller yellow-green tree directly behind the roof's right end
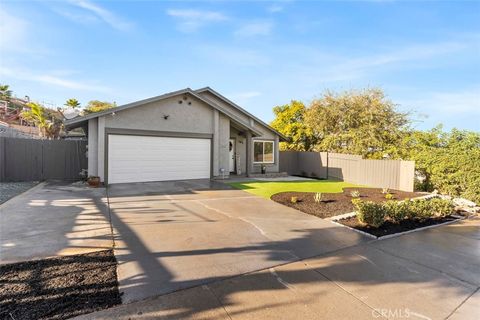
[270,100,317,151]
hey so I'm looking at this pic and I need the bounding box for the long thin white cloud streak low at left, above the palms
[0,67,110,92]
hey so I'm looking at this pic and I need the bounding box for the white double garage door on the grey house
[108,135,210,183]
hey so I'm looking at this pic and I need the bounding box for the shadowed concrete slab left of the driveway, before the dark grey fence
[0,182,112,264]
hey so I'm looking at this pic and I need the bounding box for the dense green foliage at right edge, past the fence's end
[399,125,480,203]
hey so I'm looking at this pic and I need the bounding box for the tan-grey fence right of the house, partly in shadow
[280,151,415,191]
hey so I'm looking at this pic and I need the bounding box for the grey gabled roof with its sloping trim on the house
[64,87,287,140]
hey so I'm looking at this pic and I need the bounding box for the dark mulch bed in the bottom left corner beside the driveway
[0,250,121,320]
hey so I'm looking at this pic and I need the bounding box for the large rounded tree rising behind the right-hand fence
[305,89,409,159]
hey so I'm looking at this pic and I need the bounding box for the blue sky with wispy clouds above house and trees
[0,0,480,131]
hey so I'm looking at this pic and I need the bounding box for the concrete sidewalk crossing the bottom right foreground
[78,218,480,320]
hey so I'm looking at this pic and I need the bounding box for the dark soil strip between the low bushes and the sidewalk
[337,217,457,237]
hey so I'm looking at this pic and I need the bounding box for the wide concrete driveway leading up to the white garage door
[108,180,367,303]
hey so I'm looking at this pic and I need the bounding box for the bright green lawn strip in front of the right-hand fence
[229,180,364,199]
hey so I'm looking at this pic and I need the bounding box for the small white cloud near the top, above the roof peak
[167,9,228,33]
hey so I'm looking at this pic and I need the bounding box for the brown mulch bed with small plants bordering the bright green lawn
[272,188,421,218]
